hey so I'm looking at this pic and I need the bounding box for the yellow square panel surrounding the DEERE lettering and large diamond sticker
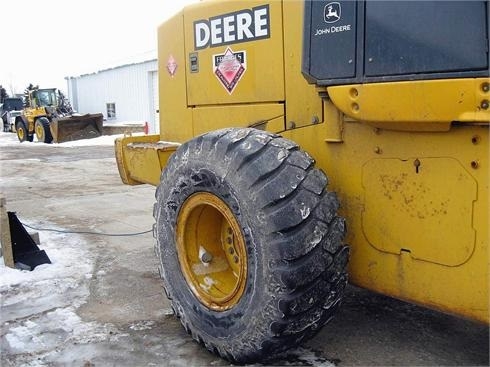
[184,1,284,106]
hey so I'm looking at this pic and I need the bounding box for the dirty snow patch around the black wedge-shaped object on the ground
[0,224,116,366]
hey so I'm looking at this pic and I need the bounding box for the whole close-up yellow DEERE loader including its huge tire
[115,0,490,363]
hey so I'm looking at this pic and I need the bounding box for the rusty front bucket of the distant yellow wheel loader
[50,113,103,143]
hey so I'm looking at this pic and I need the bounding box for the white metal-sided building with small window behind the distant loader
[65,59,159,133]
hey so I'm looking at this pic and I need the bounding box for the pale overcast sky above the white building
[0,0,198,94]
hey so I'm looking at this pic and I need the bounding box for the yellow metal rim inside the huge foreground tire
[177,192,247,311]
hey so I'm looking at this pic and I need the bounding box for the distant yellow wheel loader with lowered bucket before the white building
[15,88,103,143]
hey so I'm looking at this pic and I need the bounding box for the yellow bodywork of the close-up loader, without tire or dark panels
[119,1,490,323]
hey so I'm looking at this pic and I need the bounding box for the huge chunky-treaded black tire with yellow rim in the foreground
[154,129,349,363]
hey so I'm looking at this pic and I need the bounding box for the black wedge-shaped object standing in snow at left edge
[8,212,51,270]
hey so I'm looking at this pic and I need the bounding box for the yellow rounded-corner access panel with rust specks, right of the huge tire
[361,157,478,266]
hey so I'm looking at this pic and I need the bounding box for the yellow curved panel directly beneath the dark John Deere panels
[328,78,490,131]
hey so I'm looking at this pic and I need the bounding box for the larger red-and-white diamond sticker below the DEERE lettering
[213,47,247,94]
